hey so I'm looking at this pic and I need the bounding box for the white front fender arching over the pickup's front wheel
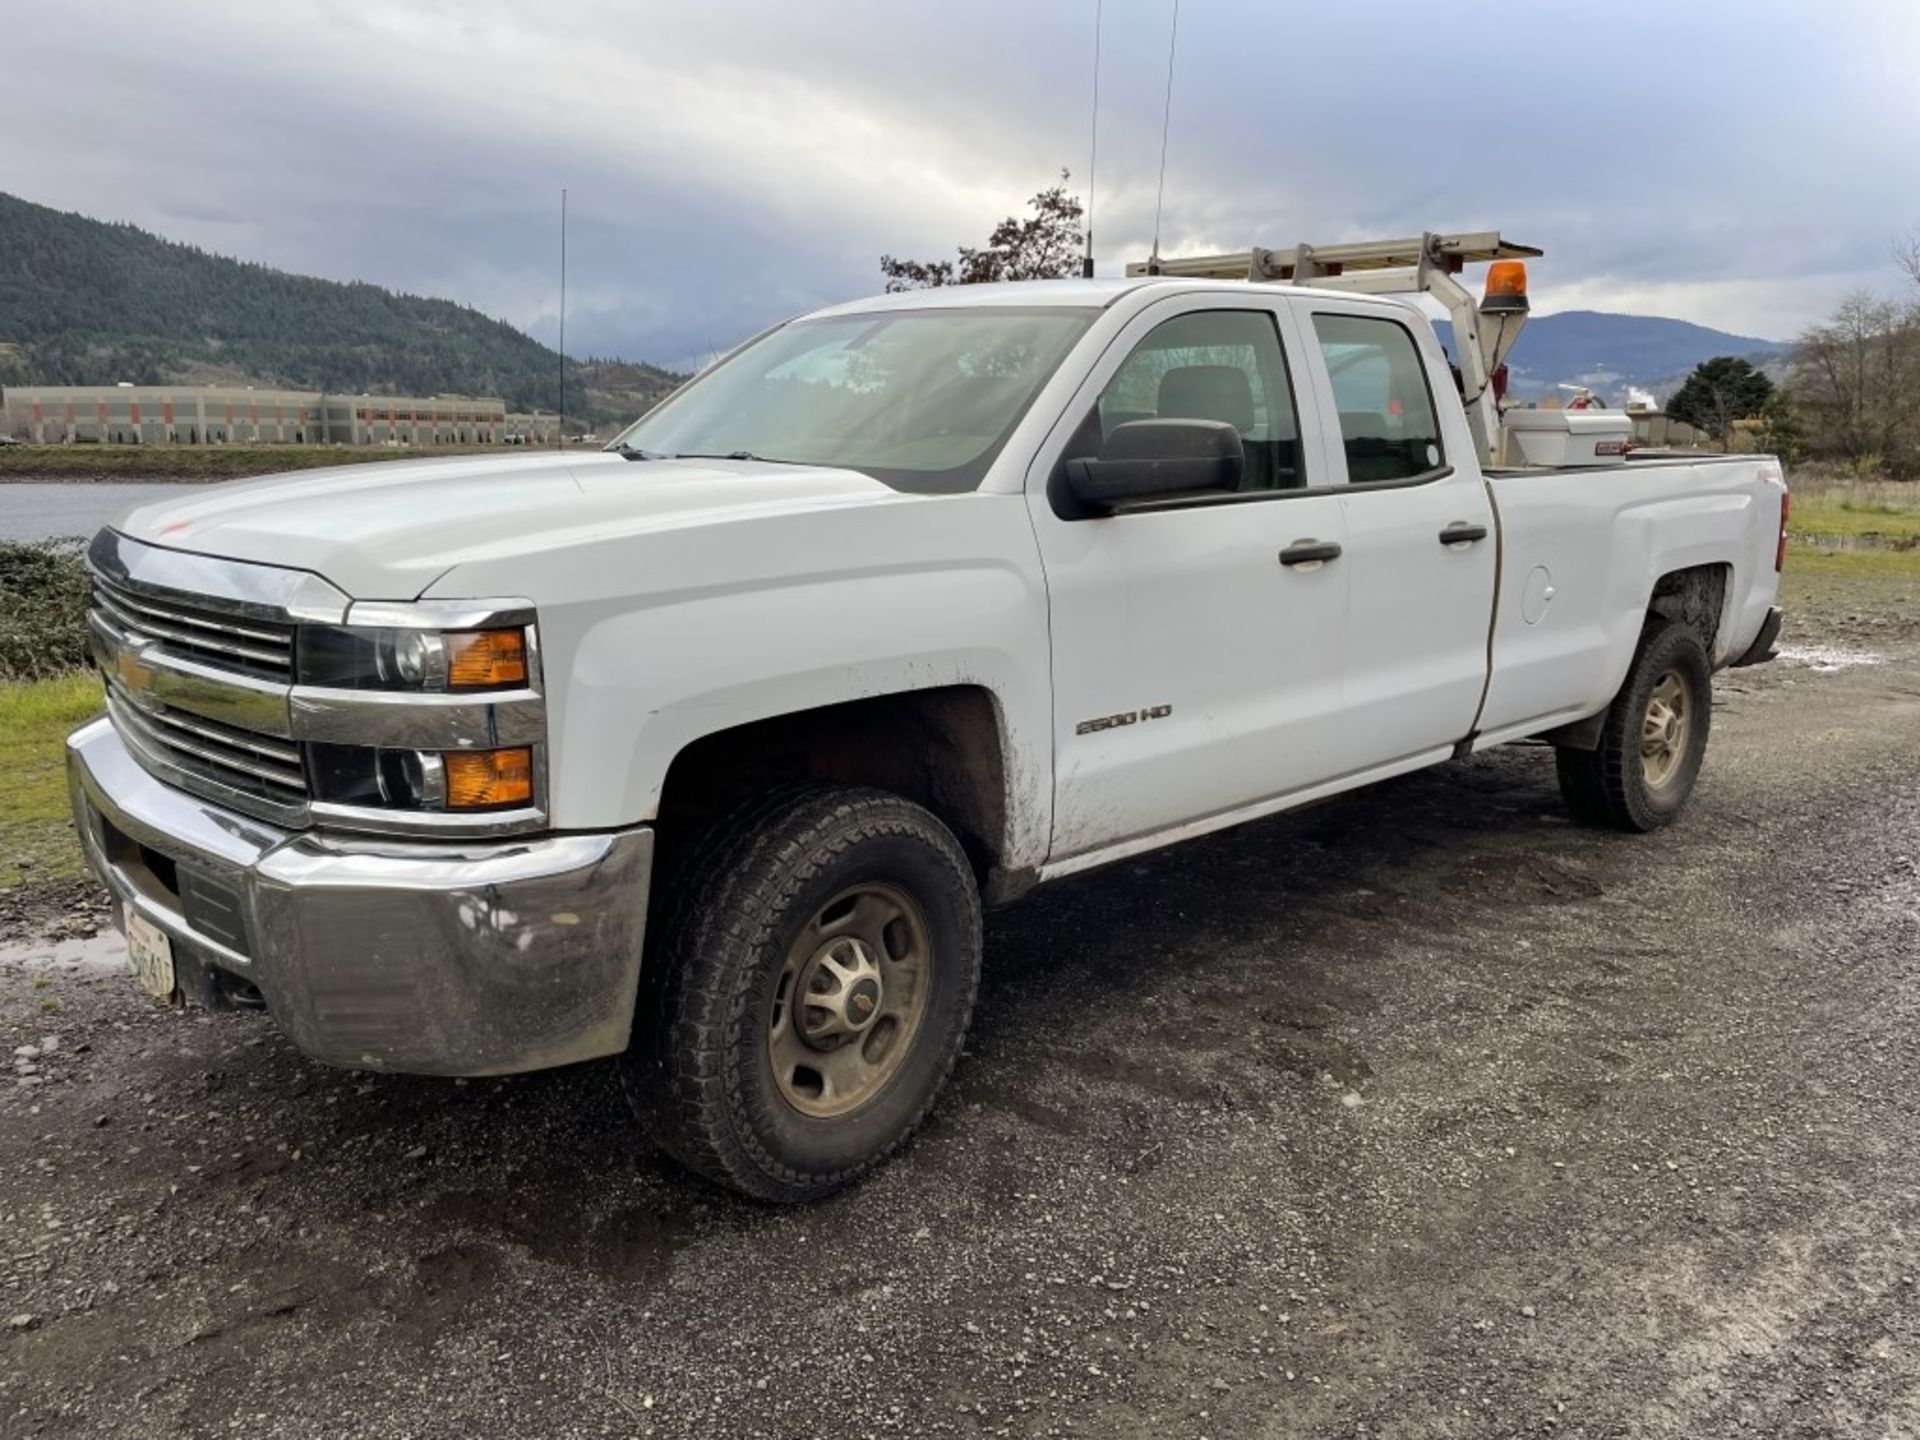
[444,495,1052,866]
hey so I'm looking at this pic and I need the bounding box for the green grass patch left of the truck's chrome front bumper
[0,674,100,889]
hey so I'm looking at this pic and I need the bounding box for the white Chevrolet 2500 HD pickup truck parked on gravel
[69,237,1786,1200]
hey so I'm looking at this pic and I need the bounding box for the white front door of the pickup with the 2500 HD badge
[1029,296,1348,864]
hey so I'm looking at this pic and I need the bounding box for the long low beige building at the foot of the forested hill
[0,386,509,445]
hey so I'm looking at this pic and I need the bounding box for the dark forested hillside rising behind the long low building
[0,194,682,422]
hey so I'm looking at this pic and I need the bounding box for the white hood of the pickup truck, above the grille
[115,451,916,599]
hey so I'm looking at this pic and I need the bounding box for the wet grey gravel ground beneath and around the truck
[0,602,1920,1440]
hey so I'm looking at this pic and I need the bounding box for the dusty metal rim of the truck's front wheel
[766,885,933,1119]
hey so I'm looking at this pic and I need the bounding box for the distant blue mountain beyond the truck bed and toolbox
[1474,309,1793,403]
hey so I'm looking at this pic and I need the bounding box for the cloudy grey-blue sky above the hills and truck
[0,0,1920,363]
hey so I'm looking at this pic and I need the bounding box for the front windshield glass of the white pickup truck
[614,307,1096,493]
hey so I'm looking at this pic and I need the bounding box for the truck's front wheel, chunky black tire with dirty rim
[622,785,981,1202]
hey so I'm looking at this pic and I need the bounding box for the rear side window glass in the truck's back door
[1313,315,1446,486]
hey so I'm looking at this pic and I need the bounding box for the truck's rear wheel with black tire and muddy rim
[1555,620,1713,833]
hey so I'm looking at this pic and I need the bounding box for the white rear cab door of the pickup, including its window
[1298,298,1498,770]
